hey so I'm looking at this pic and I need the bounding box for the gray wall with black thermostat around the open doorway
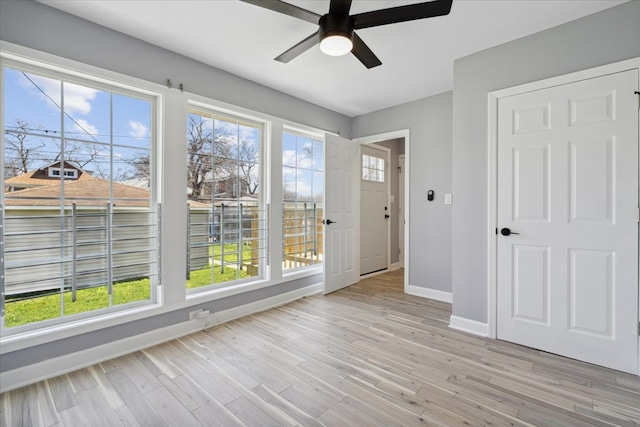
[352,92,456,292]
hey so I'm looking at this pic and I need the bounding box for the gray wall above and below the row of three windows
[0,0,351,372]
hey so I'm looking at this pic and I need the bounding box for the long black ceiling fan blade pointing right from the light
[352,0,453,30]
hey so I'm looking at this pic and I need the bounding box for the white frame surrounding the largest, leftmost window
[0,42,164,354]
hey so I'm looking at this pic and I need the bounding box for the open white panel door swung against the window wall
[324,134,360,294]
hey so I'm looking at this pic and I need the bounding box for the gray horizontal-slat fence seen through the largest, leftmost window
[0,203,159,299]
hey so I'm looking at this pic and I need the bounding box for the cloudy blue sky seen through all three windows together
[3,67,324,201]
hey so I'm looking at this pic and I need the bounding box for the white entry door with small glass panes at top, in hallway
[360,145,390,275]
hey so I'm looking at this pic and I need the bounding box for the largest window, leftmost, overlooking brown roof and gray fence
[0,65,158,331]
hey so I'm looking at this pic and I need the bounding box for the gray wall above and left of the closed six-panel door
[452,1,640,322]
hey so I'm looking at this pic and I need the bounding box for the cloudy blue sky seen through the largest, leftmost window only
[3,67,151,178]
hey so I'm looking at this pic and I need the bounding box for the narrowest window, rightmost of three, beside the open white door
[282,132,324,270]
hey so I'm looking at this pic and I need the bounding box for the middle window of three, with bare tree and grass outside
[187,110,267,289]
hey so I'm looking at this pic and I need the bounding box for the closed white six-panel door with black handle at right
[496,70,638,373]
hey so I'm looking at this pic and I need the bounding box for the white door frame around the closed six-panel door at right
[487,57,640,371]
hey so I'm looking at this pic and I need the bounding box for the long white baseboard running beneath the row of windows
[0,283,323,393]
